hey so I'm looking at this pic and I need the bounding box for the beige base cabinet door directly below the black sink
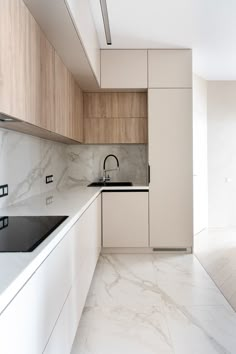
[102,190,149,248]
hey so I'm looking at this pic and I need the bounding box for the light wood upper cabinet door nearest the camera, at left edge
[0,0,40,125]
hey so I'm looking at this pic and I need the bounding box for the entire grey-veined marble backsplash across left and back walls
[0,129,147,208]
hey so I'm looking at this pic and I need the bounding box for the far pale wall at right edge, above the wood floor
[208,81,236,227]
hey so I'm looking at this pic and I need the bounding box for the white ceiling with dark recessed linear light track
[90,0,236,80]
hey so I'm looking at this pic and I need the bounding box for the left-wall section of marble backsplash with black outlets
[0,129,68,208]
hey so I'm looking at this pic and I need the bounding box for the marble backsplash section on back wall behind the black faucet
[68,145,147,185]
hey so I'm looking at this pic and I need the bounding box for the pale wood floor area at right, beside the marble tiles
[195,228,236,311]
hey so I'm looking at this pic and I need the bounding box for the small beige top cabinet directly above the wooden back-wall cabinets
[101,49,147,89]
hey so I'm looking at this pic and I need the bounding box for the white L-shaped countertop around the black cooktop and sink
[0,186,148,313]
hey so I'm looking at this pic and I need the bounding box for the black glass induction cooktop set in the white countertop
[0,216,68,252]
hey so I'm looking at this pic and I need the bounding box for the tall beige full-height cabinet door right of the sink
[148,89,193,248]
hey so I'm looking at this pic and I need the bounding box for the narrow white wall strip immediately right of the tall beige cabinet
[193,75,208,234]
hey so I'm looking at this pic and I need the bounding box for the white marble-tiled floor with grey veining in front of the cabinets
[71,254,236,354]
